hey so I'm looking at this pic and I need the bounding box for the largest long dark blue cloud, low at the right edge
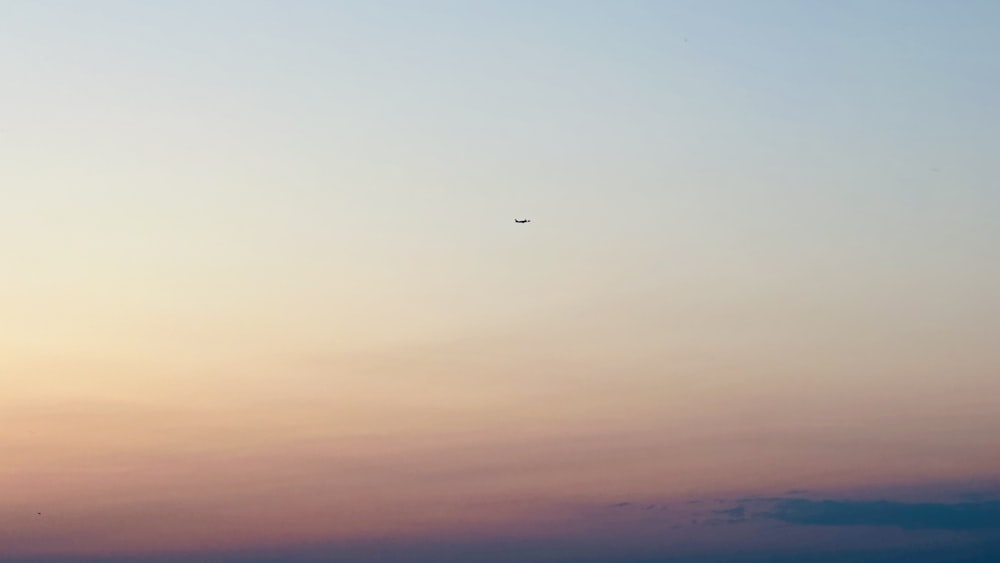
[762,498,1000,530]
